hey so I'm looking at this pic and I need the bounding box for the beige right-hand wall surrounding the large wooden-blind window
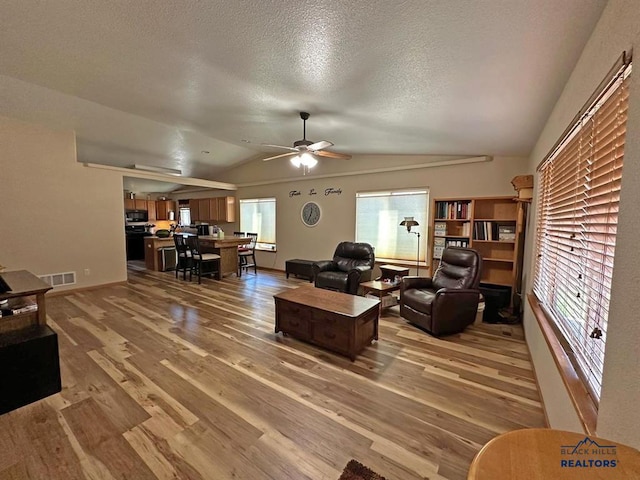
[524,0,640,448]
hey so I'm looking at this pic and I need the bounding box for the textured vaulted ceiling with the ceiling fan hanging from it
[0,0,606,179]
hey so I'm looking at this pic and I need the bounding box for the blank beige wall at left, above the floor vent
[0,117,127,290]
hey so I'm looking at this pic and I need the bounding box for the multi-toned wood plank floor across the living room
[0,268,544,480]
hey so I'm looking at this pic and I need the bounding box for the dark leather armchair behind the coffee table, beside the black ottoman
[313,242,375,295]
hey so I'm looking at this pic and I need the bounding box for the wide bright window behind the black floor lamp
[356,189,429,262]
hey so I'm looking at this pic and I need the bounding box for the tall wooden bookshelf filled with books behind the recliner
[429,196,524,302]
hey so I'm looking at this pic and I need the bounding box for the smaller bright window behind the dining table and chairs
[240,198,276,250]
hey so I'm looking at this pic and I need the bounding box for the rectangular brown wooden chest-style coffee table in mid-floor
[273,286,380,361]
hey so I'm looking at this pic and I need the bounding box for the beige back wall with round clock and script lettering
[222,155,529,270]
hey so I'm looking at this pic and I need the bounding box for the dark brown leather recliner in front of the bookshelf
[400,247,482,337]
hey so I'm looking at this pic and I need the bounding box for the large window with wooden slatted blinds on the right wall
[533,57,631,403]
